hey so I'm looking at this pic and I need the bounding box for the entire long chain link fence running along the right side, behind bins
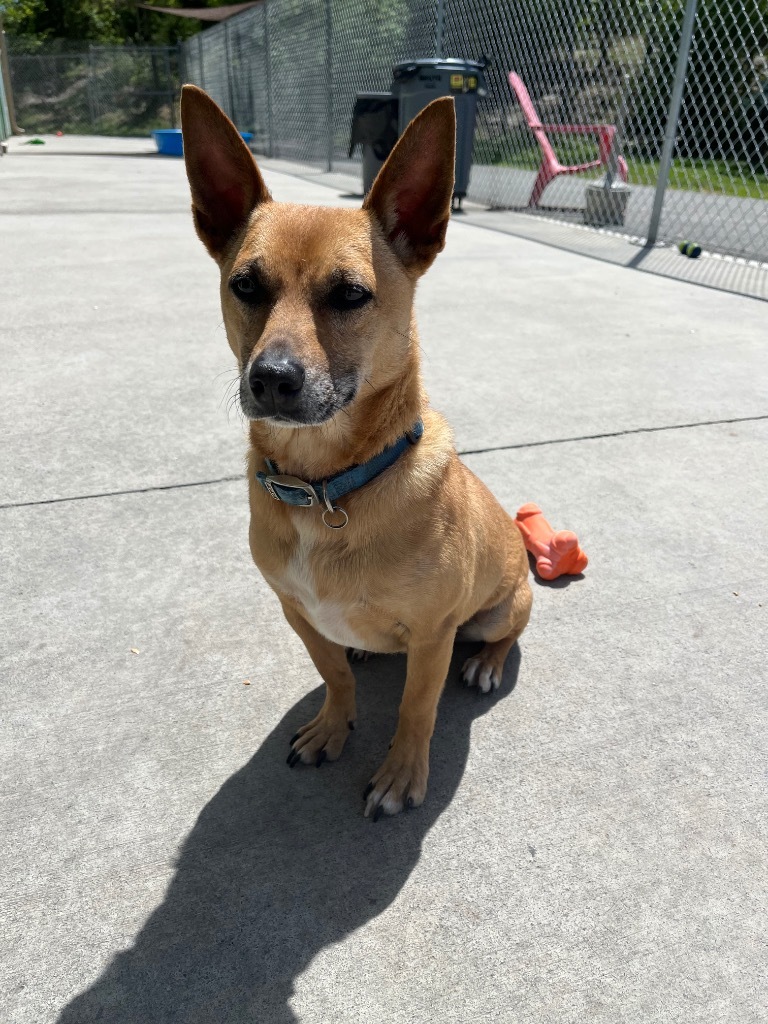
[177,0,768,261]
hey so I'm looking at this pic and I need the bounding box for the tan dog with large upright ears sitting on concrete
[181,86,531,819]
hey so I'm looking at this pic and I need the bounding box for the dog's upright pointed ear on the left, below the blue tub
[181,85,271,259]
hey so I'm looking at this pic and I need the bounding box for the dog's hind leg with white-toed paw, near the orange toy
[459,580,532,693]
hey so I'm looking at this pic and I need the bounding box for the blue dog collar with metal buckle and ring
[256,420,424,529]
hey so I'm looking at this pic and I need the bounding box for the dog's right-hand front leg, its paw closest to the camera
[364,625,456,821]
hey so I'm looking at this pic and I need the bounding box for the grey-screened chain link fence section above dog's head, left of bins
[181,0,436,170]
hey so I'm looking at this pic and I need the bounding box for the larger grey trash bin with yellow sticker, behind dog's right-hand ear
[392,57,487,206]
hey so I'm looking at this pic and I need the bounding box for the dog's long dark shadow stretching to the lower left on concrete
[58,644,520,1024]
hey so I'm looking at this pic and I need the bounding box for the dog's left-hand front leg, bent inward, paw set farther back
[282,601,356,768]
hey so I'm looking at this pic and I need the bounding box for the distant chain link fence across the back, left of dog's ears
[8,39,179,135]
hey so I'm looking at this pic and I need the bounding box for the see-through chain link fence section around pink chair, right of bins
[446,0,768,260]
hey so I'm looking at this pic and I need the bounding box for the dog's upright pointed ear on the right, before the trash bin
[362,96,456,273]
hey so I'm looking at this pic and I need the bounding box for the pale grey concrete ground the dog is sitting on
[0,140,768,1024]
